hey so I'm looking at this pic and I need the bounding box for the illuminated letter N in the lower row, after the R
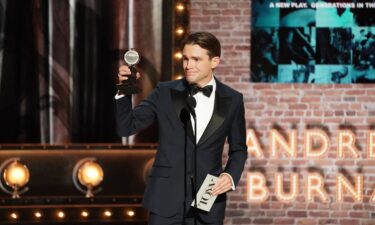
[336,174,363,202]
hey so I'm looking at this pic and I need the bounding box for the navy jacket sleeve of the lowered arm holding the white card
[224,94,247,186]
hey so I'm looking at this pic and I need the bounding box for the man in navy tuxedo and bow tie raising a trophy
[116,32,247,225]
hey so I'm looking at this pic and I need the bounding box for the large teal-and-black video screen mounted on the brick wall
[251,0,375,84]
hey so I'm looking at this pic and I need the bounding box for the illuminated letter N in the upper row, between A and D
[270,129,297,157]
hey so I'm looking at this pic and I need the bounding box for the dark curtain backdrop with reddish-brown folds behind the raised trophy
[0,0,173,144]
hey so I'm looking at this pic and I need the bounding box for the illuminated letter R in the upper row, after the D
[338,130,359,158]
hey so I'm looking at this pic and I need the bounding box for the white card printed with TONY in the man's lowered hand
[191,174,219,212]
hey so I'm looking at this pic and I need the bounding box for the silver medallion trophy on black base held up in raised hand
[116,49,141,95]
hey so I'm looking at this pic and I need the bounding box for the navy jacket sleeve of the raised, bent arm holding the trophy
[115,86,159,137]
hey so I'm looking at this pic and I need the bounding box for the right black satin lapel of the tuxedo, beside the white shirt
[198,89,232,145]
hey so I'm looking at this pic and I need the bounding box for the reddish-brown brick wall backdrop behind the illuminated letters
[190,0,375,225]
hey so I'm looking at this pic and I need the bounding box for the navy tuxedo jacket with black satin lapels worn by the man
[116,79,247,222]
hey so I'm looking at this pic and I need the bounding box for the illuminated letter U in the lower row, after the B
[275,173,299,202]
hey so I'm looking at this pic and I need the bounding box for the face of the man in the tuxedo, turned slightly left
[182,44,220,87]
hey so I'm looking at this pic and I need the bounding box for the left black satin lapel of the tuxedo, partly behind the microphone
[171,83,194,141]
